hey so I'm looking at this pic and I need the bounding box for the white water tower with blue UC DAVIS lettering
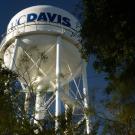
[0,5,91,134]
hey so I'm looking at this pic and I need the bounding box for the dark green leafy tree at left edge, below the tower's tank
[0,61,37,135]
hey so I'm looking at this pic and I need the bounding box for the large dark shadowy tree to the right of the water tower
[82,0,135,134]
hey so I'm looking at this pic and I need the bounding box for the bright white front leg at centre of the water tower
[55,36,61,133]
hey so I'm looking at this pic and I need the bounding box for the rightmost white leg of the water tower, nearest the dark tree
[82,61,92,134]
